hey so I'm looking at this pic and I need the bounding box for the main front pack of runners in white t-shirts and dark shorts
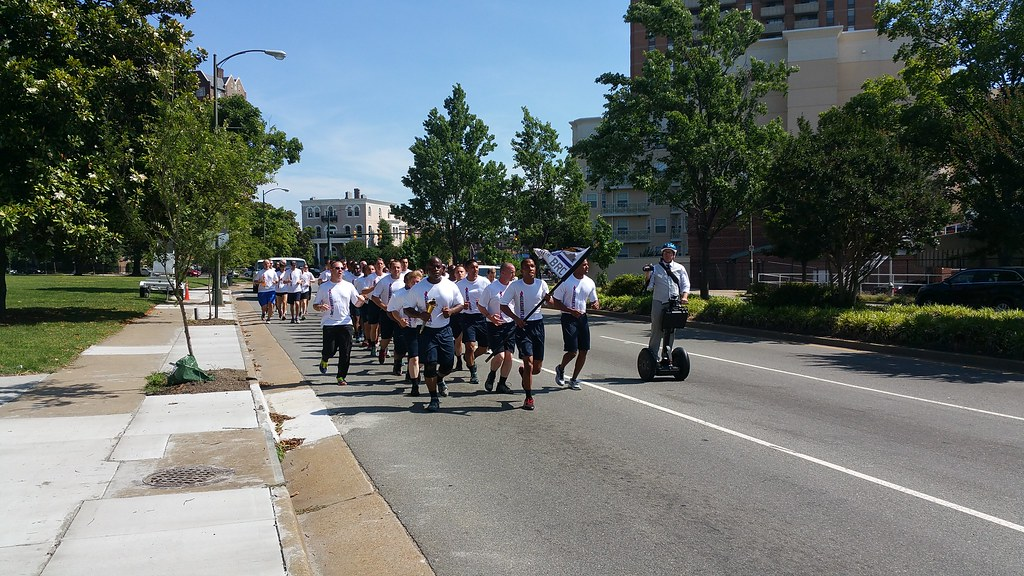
[296,253,599,411]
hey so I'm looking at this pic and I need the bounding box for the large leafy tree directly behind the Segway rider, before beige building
[572,0,796,297]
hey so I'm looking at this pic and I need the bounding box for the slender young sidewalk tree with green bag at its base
[145,94,266,356]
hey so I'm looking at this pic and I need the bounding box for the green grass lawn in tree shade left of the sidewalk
[0,275,165,375]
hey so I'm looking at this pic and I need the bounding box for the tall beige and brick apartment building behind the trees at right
[569,0,902,289]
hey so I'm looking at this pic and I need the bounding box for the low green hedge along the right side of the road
[601,294,1024,360]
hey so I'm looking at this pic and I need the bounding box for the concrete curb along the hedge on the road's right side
[587,310,1024,374]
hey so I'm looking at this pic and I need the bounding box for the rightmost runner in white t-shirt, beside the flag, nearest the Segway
[552,258,601,390]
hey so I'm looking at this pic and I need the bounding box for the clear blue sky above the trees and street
[185,0,629,220]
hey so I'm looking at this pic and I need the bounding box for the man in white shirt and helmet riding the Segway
[644,242,690,368]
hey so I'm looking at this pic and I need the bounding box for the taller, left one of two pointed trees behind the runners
[394,84,509,261]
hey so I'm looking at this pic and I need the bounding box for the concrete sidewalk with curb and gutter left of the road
[0,286,431,576]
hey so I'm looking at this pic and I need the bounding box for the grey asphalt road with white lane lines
[253,293,1024,575]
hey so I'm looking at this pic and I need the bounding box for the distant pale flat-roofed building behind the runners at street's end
[299,188,409,263]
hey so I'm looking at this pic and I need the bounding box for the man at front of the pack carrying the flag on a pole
[501,258,551,410]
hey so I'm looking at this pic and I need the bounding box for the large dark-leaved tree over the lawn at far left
[0,0,197,316]
